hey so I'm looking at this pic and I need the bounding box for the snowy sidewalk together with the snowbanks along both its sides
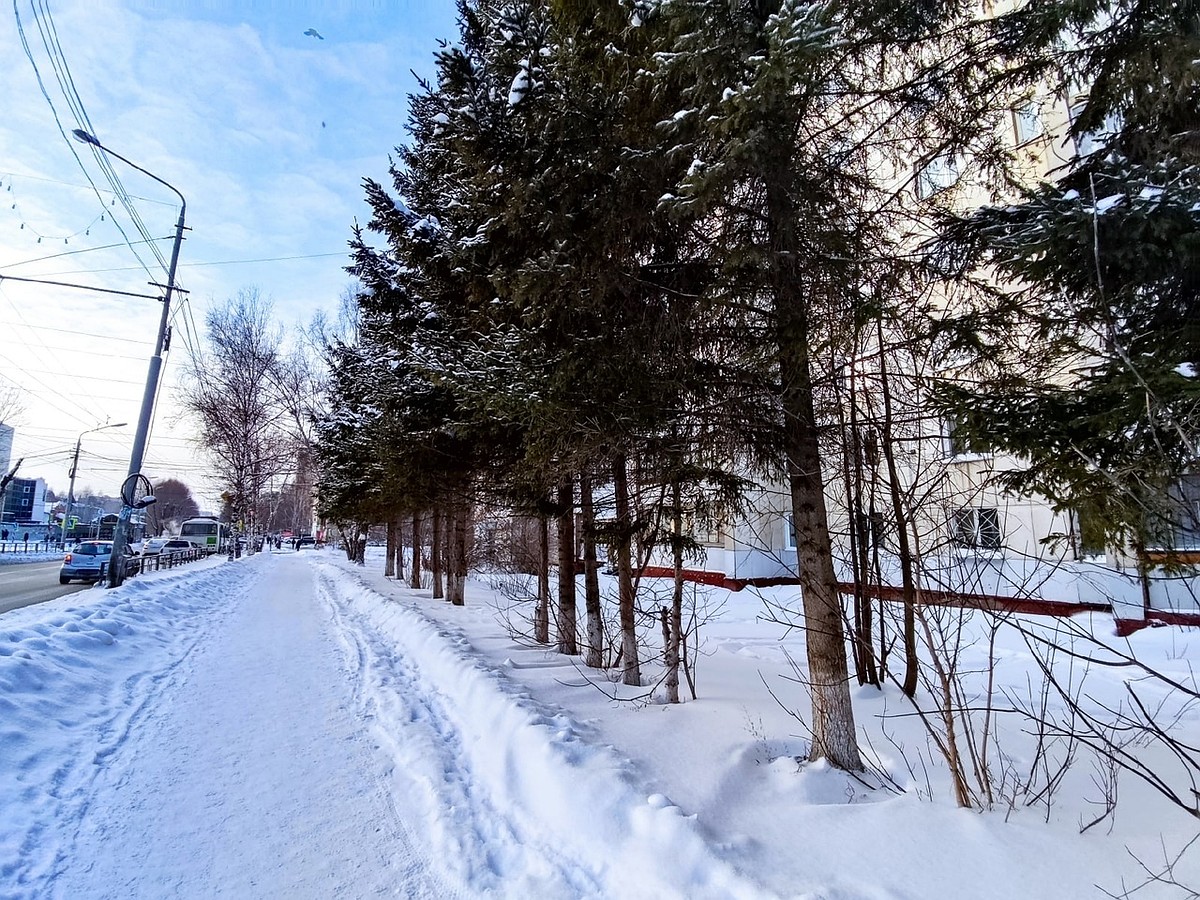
[0,553,760,898]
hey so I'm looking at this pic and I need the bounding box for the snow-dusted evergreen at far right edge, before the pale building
[934,0,1200,568]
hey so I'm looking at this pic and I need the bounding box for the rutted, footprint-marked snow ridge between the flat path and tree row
[310,558,769,900]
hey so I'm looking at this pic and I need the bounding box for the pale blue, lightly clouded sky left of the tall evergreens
[0,0,456,509]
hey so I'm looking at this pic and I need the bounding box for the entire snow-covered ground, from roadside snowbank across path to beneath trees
[0,551,1200,900]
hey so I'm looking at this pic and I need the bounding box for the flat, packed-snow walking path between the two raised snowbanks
[54,557,445,898]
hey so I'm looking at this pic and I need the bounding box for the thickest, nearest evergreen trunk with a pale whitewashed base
[767,177,863,772]
